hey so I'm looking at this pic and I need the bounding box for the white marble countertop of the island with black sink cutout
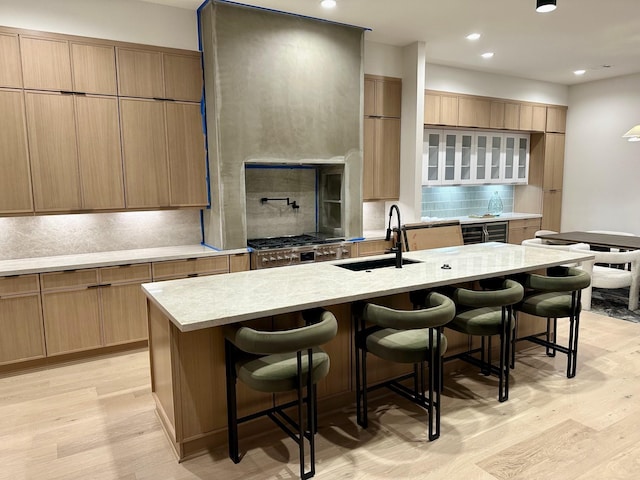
[142,242,593,331]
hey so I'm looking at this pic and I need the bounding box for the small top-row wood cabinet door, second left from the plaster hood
[116,48,164,98]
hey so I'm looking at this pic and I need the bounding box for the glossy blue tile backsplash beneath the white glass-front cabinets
[422,185,514,218]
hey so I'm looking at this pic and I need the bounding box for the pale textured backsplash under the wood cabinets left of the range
[0,210,202,260]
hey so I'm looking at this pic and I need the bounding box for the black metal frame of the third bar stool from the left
[443,305,514,402]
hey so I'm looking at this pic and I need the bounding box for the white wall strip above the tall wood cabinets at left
[0,0,198,50]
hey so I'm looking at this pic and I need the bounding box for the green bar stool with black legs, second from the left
[353,292,455,440]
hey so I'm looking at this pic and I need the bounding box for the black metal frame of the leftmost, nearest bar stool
[225,339,318,480]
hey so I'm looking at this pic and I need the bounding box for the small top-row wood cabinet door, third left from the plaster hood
[71,43,118,95]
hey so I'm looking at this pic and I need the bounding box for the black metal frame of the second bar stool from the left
[354,314,443,441]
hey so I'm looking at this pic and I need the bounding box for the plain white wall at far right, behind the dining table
[562,74,640,235]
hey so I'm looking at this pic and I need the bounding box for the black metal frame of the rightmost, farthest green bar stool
[511,290,582,378]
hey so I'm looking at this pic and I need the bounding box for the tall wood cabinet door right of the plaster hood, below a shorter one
[362,117,400,200]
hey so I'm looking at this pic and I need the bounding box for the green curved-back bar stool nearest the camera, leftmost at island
[225,309,338,479]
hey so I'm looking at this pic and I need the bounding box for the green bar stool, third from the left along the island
[445,279,524,402]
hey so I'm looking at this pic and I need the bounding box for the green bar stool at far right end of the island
[516,267,591,378]
